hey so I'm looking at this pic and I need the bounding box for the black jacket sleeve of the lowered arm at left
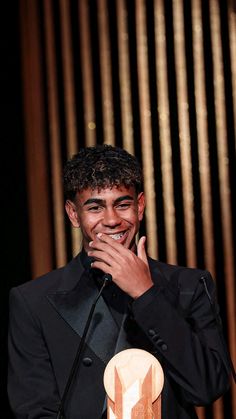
[8,288,59,419]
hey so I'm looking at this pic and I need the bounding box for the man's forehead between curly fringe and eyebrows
[76,186,136,203]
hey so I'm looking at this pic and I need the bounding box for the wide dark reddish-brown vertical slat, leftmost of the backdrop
[20,0,53,277]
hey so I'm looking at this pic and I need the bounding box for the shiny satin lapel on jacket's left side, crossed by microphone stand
[47,260,118,364]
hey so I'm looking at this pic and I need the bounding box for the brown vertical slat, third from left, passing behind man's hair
[60,0,81,255]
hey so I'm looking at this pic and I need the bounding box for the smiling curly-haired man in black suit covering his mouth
[8,146,229,419]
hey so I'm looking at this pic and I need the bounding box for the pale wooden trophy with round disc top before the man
[103,348,164,419]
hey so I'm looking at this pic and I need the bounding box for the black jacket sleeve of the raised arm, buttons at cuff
[132,271,230,405]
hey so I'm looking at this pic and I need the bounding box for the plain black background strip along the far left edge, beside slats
[0,2,31,419]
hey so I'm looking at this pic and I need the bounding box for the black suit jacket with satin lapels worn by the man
[8,256,229,419]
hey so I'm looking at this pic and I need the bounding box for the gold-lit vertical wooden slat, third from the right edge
[192,0,215,275]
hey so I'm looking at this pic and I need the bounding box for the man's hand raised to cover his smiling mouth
[88,233,153,299]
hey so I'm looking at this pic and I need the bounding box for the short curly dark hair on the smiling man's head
[64,144,142,201]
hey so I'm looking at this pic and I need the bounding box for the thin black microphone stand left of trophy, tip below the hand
[57,274,112,419]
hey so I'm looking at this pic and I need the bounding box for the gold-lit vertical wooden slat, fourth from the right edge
[173,0,196,267]
